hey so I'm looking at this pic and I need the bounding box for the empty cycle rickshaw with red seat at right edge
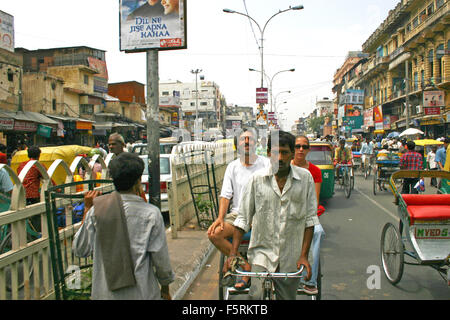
[381,170,450,286]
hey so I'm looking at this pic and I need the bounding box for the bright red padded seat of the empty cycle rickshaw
[402,194,450,224]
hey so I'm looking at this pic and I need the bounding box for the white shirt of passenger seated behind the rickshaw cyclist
[220,156,270,212]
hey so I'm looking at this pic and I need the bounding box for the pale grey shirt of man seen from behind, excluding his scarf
[72,194,175,300]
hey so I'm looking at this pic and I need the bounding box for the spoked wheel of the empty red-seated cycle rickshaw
[381,223,404,285]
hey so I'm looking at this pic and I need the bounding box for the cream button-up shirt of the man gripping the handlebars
[234,165,319,272]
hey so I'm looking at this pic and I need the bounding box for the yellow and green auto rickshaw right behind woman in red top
[306,142,335,200]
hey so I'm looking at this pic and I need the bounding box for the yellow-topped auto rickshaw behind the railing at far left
[11,145,92,185]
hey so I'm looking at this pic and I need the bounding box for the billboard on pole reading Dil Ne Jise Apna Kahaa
[119,0,187,52]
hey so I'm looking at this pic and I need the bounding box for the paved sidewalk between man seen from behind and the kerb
[166,220,215,300]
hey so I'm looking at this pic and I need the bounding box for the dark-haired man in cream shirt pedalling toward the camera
[226,130,318,300]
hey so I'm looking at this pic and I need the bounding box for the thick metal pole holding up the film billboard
[147,50,161,209]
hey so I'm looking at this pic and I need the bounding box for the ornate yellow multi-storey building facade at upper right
[353,0,450,138]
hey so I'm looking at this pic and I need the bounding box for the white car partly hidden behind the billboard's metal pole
[139,154,172,212]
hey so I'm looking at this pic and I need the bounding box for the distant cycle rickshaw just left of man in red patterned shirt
[373,149,401,195]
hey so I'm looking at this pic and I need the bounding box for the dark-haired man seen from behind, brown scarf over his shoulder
[72,152,174,300]
